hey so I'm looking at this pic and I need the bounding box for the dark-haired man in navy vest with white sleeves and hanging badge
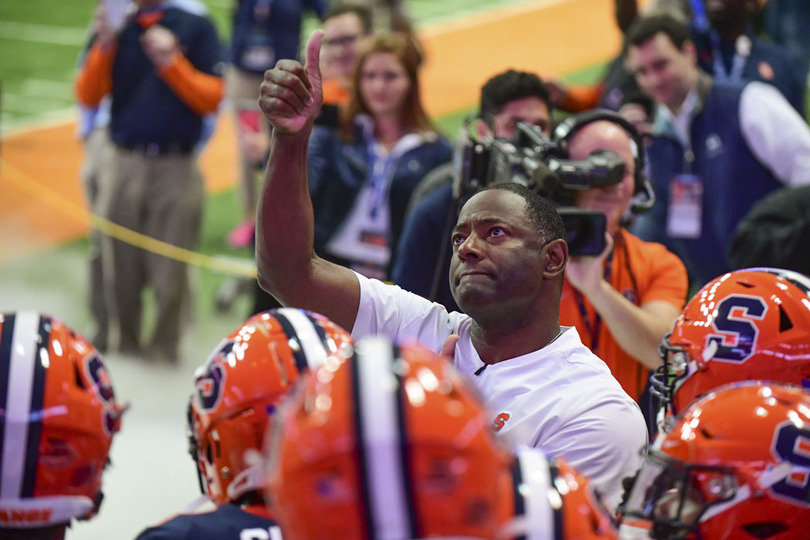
[627,15,810,289]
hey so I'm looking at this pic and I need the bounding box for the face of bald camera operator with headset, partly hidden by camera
[568,120,640,233]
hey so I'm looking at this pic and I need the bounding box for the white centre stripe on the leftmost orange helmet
[0,311,39,499]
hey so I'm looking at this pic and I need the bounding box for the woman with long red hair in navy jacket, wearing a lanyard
[308,33,452,279]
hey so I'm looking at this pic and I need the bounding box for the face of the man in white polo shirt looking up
[450,189,543,318]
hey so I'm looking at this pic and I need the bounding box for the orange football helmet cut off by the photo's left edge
[0,311,124,529]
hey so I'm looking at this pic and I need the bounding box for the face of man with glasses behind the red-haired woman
[321,13,369,79]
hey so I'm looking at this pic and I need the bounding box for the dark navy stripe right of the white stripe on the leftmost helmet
[22,317,50,497]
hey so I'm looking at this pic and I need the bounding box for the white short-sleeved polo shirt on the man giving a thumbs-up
[352,274,647,511]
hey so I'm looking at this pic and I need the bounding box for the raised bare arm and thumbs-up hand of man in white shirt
[256,30,360,331]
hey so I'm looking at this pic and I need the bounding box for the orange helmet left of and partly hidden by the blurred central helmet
[188,308,352,503]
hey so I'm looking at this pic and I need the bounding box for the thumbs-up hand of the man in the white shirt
[259,30,323,134]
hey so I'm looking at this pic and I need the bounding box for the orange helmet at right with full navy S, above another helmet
[651,268,810,429]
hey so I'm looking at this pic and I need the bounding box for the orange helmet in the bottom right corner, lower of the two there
[620,381,810,540]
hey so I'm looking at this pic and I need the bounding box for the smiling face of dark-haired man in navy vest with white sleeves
[627,32,697,111]
